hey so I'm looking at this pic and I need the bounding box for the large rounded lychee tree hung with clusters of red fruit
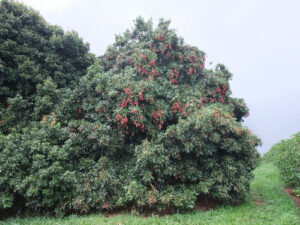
[58,18,260,213]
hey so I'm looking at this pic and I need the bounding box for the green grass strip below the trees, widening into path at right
[0,161,300,225]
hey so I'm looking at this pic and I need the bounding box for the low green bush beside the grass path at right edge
[264,132,300,197]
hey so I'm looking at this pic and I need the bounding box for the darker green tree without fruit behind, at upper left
[0,0,94,133]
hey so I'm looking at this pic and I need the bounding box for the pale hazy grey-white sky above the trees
[22,0,300,153]
